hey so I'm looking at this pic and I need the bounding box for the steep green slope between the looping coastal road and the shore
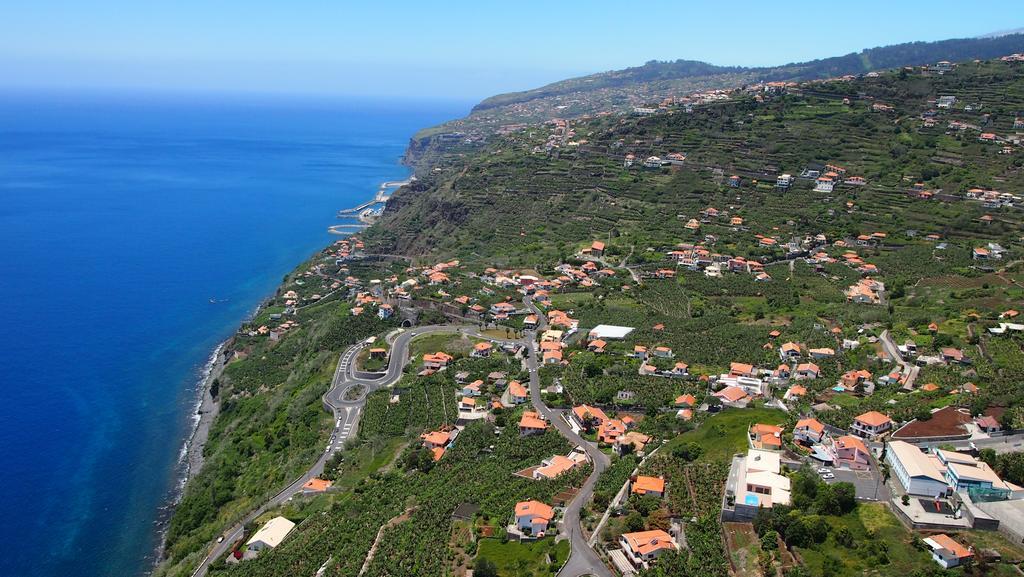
[159,274,388,573]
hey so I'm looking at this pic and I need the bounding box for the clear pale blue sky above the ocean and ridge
[0,0,1024,99]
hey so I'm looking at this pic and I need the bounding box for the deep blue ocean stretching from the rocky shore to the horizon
[0,93,468,577]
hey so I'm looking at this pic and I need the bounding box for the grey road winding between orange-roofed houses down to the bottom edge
[524,298,612,577]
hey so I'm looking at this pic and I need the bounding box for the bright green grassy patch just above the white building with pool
[664,408,786,461]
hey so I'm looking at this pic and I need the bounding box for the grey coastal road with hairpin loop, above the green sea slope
[193,325,501,577]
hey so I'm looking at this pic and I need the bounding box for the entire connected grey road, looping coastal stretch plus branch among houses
[193,309,612,577]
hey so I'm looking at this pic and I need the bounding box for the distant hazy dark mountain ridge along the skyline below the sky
[472,33,1024,113]
